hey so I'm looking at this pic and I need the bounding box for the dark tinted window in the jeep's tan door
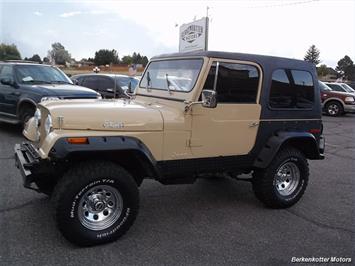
[204,63,259,103]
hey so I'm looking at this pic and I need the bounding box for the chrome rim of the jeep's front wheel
[78,185,123,231]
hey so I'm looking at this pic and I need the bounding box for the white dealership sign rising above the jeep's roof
[179,18,208,52]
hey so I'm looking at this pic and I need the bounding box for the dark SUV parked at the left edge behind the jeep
[0,62,101,124]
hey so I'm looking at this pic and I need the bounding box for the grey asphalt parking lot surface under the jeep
[0,115,355,265]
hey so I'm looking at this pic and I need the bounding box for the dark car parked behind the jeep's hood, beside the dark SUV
[71,73,139,99]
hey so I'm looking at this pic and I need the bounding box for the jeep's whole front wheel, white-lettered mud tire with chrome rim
[53,162,139,246]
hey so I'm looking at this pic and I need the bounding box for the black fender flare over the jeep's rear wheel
[253,131,320,168]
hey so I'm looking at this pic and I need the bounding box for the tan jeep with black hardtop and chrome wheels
[15,52,324,245]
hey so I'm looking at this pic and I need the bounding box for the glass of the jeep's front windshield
[139,59,203,92]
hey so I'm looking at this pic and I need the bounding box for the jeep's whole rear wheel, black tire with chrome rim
[253,147,309,209]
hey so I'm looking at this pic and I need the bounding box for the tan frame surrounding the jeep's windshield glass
[137,57,205,93]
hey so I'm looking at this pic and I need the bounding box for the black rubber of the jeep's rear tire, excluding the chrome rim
[252,147,309,209]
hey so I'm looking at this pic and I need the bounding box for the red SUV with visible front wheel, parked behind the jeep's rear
[319,81,355,116]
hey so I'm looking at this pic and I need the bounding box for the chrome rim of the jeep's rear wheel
[275,162,301,196]
